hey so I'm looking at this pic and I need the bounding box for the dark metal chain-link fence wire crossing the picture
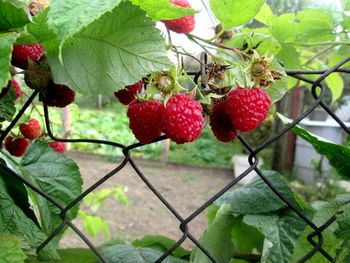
[0,53,350,263]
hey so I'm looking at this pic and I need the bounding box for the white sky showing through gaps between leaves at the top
[158,0,341,53]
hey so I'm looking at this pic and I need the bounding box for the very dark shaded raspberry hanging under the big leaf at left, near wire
[39,83,75,108]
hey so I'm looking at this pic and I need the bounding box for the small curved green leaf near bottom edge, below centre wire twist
[132,235,191,258]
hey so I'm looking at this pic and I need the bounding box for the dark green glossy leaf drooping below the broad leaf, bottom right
[243,210,306,263]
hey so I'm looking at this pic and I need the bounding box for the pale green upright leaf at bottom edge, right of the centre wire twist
[191,204,236,263]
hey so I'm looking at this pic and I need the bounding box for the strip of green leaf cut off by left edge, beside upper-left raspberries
[0,32,17,88]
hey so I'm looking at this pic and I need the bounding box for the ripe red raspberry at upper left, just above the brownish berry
[12,44,45,69]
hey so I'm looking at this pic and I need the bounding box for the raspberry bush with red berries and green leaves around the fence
[0,0,350,263]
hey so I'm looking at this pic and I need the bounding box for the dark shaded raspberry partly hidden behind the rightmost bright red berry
[210,101,238,142]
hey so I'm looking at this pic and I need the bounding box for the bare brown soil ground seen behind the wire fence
[61,152,233,251]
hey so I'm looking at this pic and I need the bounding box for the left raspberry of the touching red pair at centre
[128,100,162,144]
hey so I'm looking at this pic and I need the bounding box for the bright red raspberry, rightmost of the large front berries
[226,87,271,132]
